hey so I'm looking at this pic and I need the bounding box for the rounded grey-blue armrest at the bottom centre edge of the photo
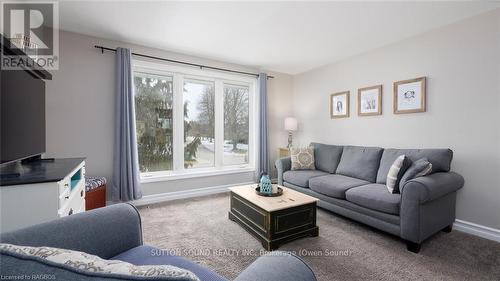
[234,251,316,281]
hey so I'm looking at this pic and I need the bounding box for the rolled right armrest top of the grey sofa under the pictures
[401,172,464,203]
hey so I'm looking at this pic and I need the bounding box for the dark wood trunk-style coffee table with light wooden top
[229,185,319,248]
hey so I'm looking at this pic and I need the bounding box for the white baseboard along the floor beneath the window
[130,182,253,206]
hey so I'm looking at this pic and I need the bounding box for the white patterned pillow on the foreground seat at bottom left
[0,243,200,281]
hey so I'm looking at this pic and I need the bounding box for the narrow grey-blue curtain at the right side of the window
[256,73,271,180]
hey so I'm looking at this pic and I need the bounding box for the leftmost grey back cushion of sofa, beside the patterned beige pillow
[311,142,344,174]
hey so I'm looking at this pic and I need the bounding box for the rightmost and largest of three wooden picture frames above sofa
[393,77,427,114]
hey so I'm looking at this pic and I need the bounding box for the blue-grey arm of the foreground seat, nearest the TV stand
[0,203,142,259]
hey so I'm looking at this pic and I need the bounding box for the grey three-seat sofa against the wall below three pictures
[276,143,464,252]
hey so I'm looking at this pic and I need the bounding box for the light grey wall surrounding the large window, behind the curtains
[46,31,291,195]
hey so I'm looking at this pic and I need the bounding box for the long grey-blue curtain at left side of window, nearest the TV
[112,48,142,201]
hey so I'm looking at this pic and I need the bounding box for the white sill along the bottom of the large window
[140,167,255,183]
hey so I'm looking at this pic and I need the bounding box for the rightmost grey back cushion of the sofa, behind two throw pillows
[377,148,453,184]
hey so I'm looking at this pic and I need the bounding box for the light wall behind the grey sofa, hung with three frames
[293,9,500,229]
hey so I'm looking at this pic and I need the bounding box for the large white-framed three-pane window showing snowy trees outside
[134,61,256,180]
